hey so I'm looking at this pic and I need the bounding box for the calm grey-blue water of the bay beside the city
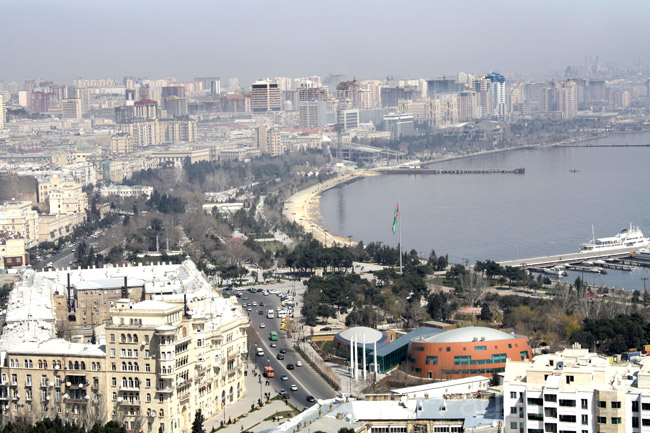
[320,133,650,289]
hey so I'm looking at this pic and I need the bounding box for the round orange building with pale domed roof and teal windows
[406,326,532,380]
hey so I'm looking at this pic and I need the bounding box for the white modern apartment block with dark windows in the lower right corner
[503,346,650,433]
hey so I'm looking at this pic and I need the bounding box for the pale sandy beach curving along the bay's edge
[282,170,379,247]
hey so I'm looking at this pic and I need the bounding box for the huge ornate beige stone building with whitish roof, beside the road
[0,260,248,433]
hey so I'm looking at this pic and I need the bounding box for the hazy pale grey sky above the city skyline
[0,0,650,83]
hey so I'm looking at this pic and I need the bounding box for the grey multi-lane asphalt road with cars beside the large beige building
[240,292,338,409]
